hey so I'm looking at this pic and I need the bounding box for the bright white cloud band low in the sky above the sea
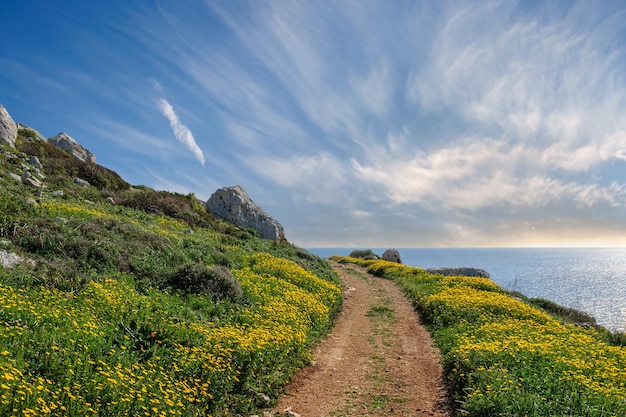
[352,132,626,211]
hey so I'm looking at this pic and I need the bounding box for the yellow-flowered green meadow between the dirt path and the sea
[333,256,626,417]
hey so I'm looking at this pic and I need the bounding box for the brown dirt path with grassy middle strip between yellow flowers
[265,264,449,417]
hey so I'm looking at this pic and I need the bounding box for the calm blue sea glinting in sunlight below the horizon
[307,248,626,332]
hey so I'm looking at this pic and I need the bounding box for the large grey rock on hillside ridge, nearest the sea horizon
[205,185,285,241]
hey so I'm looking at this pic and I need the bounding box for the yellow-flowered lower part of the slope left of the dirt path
[0,253,340,416]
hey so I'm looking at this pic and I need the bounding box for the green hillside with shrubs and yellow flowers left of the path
[0,129,341,416]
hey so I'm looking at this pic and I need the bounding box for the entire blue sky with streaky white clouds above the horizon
[0,0,626,247]
